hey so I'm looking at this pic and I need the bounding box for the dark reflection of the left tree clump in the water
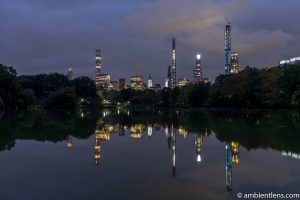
[0,112,96,150]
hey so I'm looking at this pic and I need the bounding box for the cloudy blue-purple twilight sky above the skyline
[0,0,300,84]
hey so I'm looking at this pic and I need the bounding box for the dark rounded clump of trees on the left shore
[0,64,99,110]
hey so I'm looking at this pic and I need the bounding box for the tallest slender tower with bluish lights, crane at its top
[225,20,231,75]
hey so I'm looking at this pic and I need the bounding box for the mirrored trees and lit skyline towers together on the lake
[0,109,300,196]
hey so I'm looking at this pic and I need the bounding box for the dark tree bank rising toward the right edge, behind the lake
[107,66,300,108]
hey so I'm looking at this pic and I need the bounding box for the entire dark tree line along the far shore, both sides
[0,65,300,109]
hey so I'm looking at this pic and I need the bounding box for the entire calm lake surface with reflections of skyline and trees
[0,109,300,200]
